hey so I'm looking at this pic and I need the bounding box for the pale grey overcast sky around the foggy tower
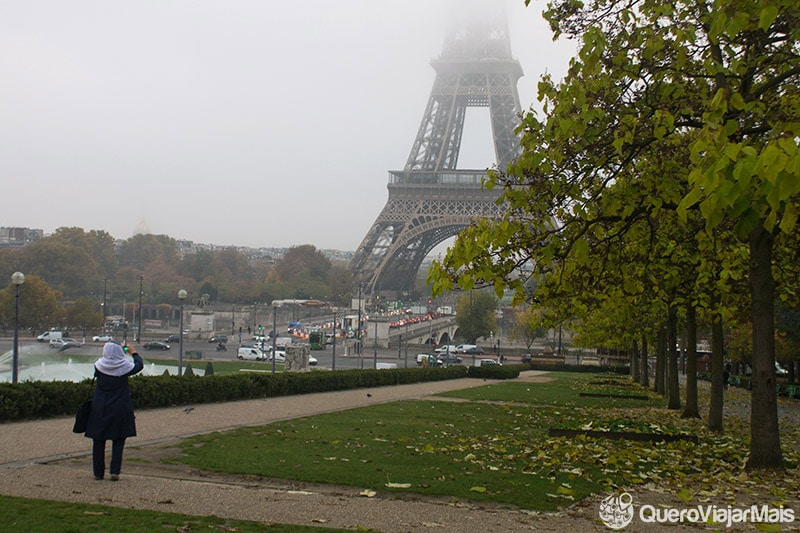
[0,0,573,250]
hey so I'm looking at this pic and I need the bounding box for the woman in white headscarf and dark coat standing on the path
[84,341,144,481]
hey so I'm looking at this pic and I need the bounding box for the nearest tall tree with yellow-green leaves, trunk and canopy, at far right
[431,0,800,468]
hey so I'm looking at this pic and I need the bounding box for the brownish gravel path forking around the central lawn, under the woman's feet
[0,372,800,533]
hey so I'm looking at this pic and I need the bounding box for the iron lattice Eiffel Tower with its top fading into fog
[351,0,522,294]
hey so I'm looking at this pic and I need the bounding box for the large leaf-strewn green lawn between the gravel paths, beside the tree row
[169,373,792,511]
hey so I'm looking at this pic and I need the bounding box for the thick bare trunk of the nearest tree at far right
[747,223,784,469]
